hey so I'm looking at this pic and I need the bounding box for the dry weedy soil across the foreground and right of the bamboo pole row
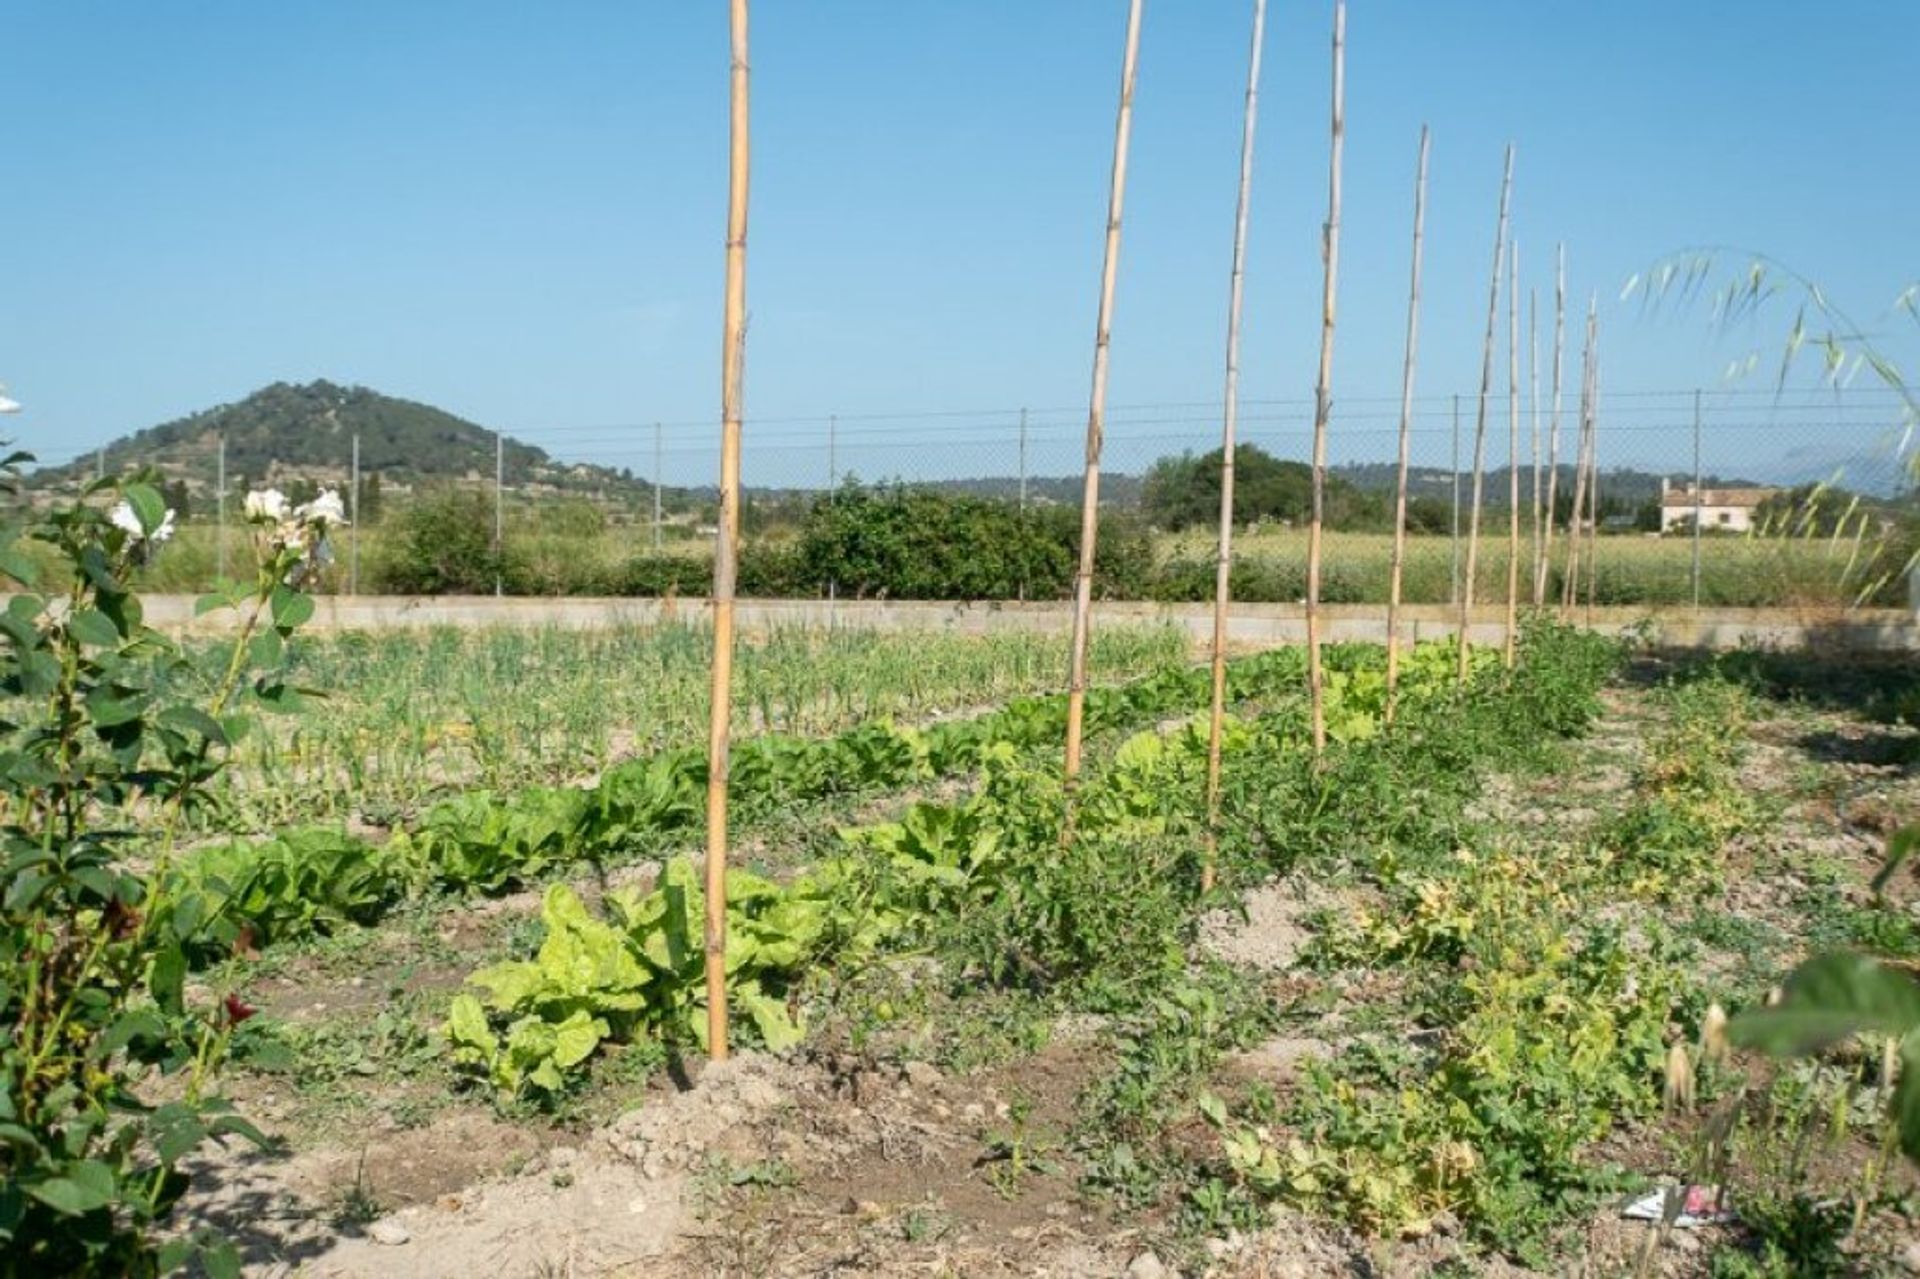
[153,633,1920,1275]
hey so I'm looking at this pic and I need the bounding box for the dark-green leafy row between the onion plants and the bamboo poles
[156,649,1379,960]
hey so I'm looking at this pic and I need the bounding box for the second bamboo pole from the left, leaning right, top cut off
[1066,0,1140,787]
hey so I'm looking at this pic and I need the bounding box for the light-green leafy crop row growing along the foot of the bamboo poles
[447,641,1501,1097]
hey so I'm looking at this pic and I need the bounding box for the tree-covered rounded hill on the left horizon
[31,380,651,499]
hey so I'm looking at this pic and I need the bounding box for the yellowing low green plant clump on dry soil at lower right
[1225,844,1686,1262]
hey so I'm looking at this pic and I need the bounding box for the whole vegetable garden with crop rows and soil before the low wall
[11,470,1920,1275]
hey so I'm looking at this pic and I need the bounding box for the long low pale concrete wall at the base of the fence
[116,595,1920,651]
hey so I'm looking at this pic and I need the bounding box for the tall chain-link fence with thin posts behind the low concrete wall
[30,388,1914,605]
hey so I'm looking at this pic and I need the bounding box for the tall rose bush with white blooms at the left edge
[0,470,340,1277]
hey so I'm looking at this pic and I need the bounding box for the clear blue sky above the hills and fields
[0,0,1920,480]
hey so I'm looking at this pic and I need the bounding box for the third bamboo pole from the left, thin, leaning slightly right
[1200,0,1267,891]
